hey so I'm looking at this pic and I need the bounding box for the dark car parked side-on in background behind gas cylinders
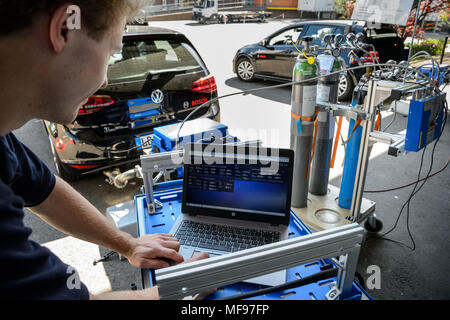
[233,20,408,100]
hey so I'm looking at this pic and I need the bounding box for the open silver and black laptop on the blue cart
[170,144,294,286]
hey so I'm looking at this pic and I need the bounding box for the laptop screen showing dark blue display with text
[183,148,293,224]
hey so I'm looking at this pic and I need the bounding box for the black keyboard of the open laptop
[174,221,280,252]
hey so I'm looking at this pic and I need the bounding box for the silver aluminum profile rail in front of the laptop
[155,223,364,300]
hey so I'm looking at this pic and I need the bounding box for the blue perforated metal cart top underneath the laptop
[135,180,371,300]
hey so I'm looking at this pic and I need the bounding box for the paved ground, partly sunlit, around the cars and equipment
[16,21,450,299]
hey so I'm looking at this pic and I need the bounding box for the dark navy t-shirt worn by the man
[0,134,89,300]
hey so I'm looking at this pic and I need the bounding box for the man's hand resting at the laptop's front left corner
[125,233,184,269]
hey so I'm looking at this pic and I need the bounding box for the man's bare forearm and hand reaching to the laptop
[30,177,183,269]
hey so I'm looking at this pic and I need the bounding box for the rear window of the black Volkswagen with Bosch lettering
[108,39,204,84]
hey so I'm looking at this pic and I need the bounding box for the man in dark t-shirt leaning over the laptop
[0,0,207,299]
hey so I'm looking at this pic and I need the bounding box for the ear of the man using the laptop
[49,4,70,53]
